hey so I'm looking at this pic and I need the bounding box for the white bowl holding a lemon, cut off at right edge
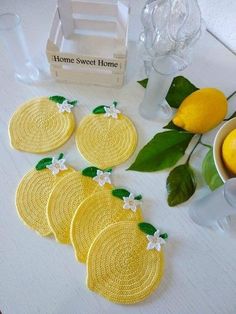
[213,118,236,182]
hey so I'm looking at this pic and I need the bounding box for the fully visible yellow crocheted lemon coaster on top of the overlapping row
[87,221,167,304]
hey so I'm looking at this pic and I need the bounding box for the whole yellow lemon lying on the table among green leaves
[173,88,228,133]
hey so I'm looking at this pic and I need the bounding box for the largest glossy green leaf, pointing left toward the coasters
[128,130,194,172]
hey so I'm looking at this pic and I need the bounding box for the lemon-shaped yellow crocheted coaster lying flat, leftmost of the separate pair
[9,96,76,153]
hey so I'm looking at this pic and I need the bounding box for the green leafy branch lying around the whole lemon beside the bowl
[134,76,236,206]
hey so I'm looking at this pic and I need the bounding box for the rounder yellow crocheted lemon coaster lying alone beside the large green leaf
[76,103,137,169]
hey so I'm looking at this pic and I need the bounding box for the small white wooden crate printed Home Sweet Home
[47,0,129,87]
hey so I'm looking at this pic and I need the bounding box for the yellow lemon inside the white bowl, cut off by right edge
[222,129,236,175]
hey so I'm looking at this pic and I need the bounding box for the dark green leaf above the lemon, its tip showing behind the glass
[138,76,198,108]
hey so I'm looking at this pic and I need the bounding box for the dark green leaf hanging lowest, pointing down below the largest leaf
[166,164,196,206]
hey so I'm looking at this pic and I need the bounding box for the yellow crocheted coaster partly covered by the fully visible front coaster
[70,189,142,263]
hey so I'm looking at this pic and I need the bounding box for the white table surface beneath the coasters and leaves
[0,0,236,314]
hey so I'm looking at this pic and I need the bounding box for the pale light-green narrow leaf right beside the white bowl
[202,148,223,191]
